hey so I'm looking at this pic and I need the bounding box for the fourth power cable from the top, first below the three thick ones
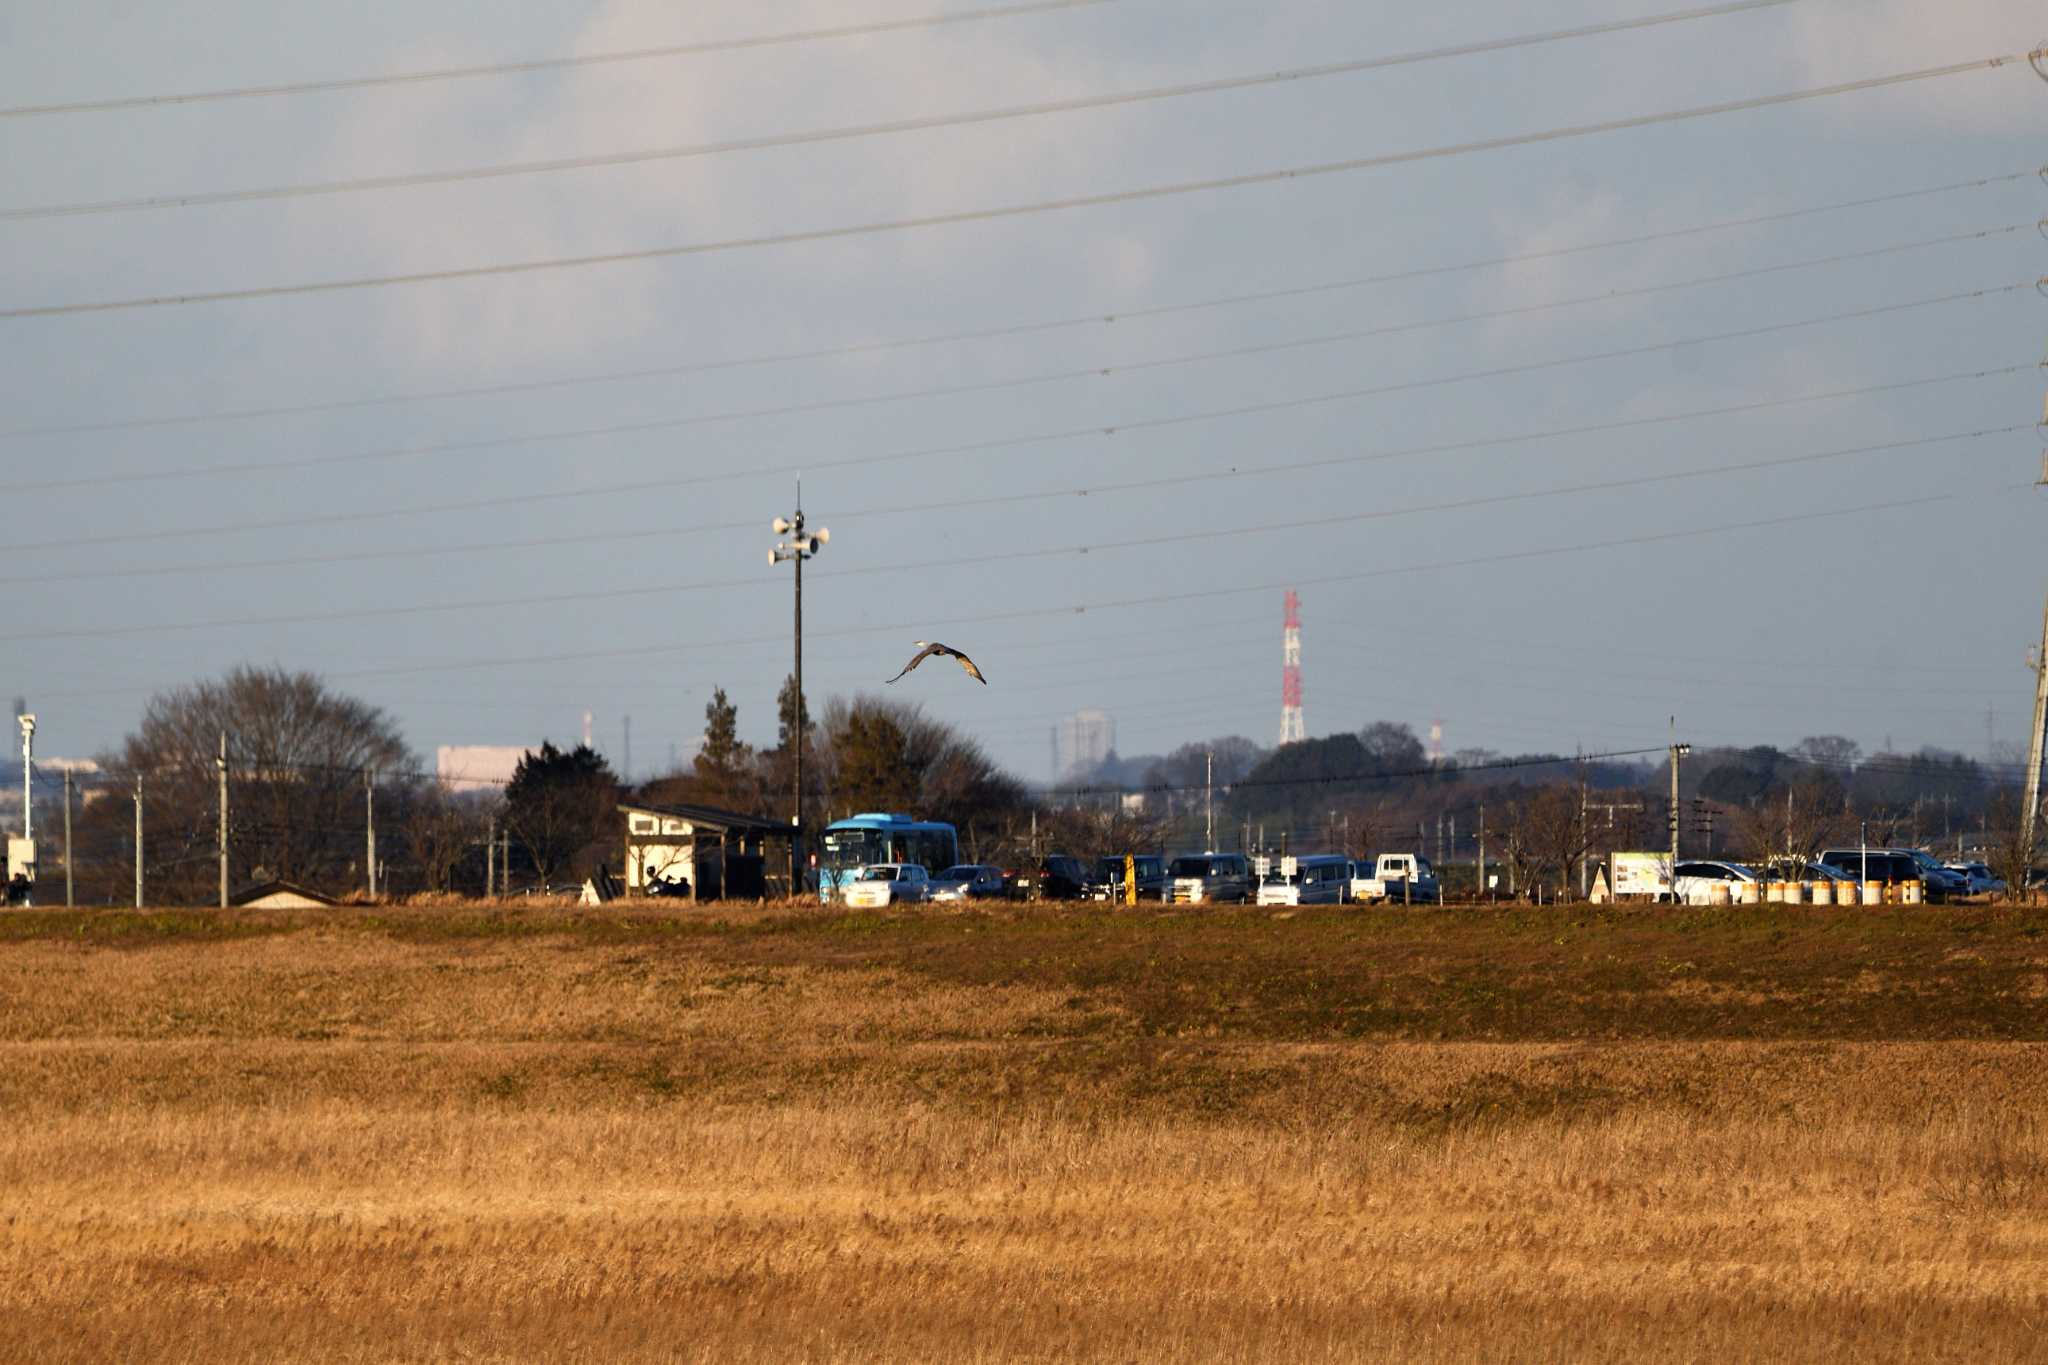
[0,170,2036,440]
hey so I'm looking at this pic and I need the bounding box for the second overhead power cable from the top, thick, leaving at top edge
[0,0,1800,221]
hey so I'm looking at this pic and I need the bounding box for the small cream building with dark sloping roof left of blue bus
[618,804,791,900]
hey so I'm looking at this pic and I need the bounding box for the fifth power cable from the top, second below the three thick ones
[8,223,2032,495]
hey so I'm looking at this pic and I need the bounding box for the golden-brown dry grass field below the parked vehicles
[0,909,2048,1363]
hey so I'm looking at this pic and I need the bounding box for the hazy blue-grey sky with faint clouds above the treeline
[0,0,2048,778]
